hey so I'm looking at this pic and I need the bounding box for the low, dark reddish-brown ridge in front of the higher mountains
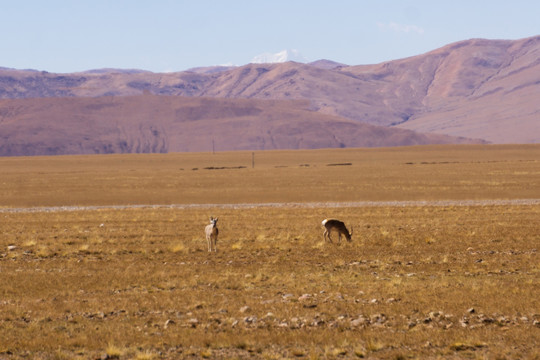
[0,95,480,156]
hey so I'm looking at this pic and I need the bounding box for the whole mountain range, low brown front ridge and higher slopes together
[0,36,540,156]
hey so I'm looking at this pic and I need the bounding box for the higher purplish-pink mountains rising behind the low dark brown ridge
[0,36,540,143]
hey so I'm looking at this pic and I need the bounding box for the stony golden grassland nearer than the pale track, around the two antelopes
[0,205,540,358]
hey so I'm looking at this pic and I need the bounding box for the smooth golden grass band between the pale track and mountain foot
[0,145,540,207]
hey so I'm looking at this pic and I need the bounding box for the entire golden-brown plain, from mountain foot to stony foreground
[0,145,540,359]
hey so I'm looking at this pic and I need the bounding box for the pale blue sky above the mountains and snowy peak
[0,0,540,72]
